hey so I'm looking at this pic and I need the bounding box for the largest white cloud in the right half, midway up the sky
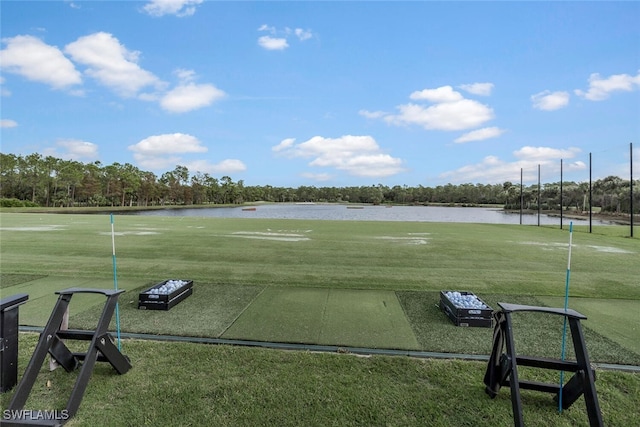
[368,83,494,131]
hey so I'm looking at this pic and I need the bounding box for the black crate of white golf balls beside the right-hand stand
[440,291,493,328]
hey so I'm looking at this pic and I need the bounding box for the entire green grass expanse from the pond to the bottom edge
[0,212,640,426]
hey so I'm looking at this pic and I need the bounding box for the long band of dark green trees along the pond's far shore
[0,153,640,214]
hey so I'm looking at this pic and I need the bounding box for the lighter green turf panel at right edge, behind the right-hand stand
[538,297,640,354]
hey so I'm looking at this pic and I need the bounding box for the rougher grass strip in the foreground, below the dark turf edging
[0,333,640,427]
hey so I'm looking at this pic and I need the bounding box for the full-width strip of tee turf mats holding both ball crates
[3,277,640,365]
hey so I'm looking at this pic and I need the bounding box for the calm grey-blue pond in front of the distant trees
[129,203,609,226]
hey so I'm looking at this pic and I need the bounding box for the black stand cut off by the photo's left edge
[0,294,29,393]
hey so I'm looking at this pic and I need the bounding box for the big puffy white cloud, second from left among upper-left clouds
[65,32,163,97]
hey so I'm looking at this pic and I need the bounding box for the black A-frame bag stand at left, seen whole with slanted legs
[2,288,131,426]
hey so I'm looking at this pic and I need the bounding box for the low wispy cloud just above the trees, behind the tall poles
[440,146,587,183]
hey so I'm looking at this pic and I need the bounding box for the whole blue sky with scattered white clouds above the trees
[0,0,640,187]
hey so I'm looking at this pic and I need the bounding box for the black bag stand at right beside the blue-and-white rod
[484,302,604,427]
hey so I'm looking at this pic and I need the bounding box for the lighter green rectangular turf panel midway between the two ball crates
[223,288,420,350]
